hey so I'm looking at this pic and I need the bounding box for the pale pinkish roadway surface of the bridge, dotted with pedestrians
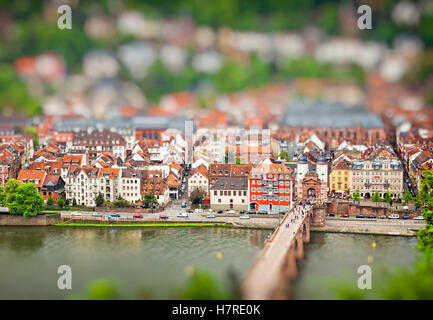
[241,205,311,300]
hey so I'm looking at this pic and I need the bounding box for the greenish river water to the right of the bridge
[294,232,417,299]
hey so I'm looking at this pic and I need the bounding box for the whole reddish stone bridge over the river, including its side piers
[241,204,326,300]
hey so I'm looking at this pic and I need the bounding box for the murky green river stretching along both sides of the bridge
[0,227,416,299]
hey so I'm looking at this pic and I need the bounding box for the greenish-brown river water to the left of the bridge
[0,227,267,299]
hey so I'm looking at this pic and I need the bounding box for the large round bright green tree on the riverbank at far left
[8,183,44,217]
